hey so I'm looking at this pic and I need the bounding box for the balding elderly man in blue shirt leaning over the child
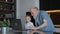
[30,7,55,32]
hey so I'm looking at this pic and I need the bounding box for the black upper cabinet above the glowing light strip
[40,0,60,10]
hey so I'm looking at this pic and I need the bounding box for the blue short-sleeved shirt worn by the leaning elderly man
[35,11,55,32]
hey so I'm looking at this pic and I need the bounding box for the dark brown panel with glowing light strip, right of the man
[47,10,60,28]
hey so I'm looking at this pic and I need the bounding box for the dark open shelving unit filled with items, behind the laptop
[0,0,16,26]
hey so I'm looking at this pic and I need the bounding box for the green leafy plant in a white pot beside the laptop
[0,19,10,34]
